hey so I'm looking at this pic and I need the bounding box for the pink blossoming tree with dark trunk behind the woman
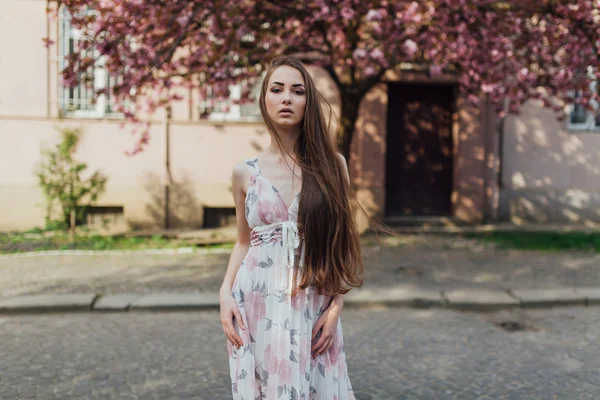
[50,0,600,157]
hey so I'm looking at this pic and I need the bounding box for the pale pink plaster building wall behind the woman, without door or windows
[0,0,600,230]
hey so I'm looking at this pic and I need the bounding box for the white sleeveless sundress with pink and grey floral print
[227,158,354,400]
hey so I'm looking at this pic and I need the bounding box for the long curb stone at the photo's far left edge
[0,293,97,313]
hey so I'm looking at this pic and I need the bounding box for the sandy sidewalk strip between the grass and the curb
[0,235,600,297]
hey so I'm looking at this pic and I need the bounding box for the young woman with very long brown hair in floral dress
[220,57,363,400]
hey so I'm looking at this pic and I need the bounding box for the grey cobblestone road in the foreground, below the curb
[0,308,600,400]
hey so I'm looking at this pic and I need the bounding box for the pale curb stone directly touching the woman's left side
[131,293,219,310]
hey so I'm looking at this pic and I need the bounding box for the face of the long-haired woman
[265,65,306,128]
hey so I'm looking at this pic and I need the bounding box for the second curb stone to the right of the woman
[443,289,520,310]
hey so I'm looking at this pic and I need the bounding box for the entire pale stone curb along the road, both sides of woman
[0,286,600,314]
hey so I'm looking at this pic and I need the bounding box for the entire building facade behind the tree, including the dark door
[0,0,600,231]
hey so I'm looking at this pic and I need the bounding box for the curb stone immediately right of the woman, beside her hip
[344,285,445,307]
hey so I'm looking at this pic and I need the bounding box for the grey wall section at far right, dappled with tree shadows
[500,101,600,225]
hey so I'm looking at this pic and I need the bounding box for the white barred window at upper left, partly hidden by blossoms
[58,7,116,118]
